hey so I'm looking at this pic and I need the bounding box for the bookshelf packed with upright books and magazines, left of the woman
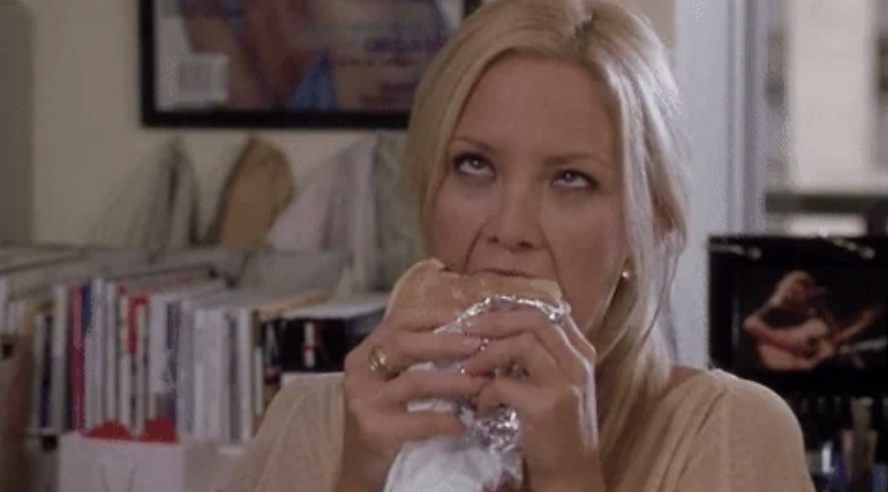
[0,246,380,492]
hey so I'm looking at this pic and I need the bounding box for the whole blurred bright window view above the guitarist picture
[764,0,888,235]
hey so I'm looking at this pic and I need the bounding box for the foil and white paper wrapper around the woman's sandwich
[384,296,570,492]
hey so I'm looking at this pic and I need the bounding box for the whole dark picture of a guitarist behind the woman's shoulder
[708,235,888,396]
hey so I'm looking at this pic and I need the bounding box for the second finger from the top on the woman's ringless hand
[463,332,567,386]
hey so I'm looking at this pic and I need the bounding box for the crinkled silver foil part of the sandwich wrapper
[436,296,570,481]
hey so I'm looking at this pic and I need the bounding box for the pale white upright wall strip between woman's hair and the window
[673,0,766,367]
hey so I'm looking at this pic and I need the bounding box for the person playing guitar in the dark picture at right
[743,270,881,371]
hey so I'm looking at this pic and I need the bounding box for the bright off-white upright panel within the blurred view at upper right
[784,0,888,191]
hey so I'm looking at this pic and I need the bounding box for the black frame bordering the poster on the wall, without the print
[138,0,481,129]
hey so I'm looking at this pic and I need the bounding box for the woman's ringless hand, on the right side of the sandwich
[465,308,604,492]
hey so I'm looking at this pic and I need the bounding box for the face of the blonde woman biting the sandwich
[430,56,628,331]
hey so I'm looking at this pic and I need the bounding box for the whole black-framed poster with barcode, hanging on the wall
[139,0,480,128]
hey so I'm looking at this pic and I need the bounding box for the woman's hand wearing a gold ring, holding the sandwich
[337,309,485,492]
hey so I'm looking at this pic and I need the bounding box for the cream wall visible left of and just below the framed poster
[25,0,361,243]
